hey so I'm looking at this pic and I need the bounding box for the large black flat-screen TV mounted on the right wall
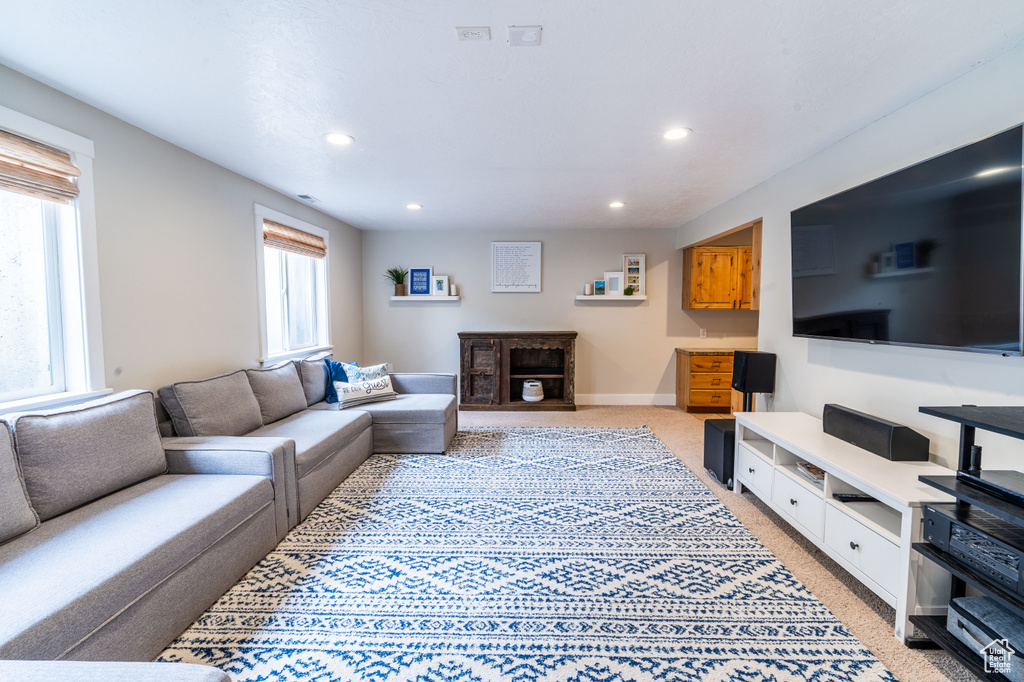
[791,126,1022,355]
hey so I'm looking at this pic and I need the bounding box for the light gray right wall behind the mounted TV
[677,43,1024,469]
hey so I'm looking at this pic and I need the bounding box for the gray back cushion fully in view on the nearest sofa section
[12,391,167,521]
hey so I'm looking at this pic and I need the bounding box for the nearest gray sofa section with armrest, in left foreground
[0,391,285,659]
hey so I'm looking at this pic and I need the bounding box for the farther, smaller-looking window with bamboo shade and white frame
[256,205,330,361]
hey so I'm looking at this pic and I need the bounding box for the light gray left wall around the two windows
[0,67,362,390]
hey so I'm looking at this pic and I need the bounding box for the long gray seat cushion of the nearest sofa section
[0,474,273,658]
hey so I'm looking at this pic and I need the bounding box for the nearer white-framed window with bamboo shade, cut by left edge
[0,106,109,413]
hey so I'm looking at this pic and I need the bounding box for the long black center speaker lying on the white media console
[821,404,928,462]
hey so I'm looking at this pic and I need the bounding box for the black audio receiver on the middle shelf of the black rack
[924,503,1024,595]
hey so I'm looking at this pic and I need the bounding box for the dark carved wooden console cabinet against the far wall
[459,332,577,410]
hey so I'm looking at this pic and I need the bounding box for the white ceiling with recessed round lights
[0,0,1024,229]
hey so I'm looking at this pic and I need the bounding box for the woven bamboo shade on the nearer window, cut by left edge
[0,130,82,204]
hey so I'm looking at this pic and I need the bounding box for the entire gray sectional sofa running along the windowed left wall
[0,360,458,681]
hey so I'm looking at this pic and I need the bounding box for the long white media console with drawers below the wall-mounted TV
[733,412,955,642]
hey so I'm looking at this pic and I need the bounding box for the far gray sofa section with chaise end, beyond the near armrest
[159,358,459,525]
